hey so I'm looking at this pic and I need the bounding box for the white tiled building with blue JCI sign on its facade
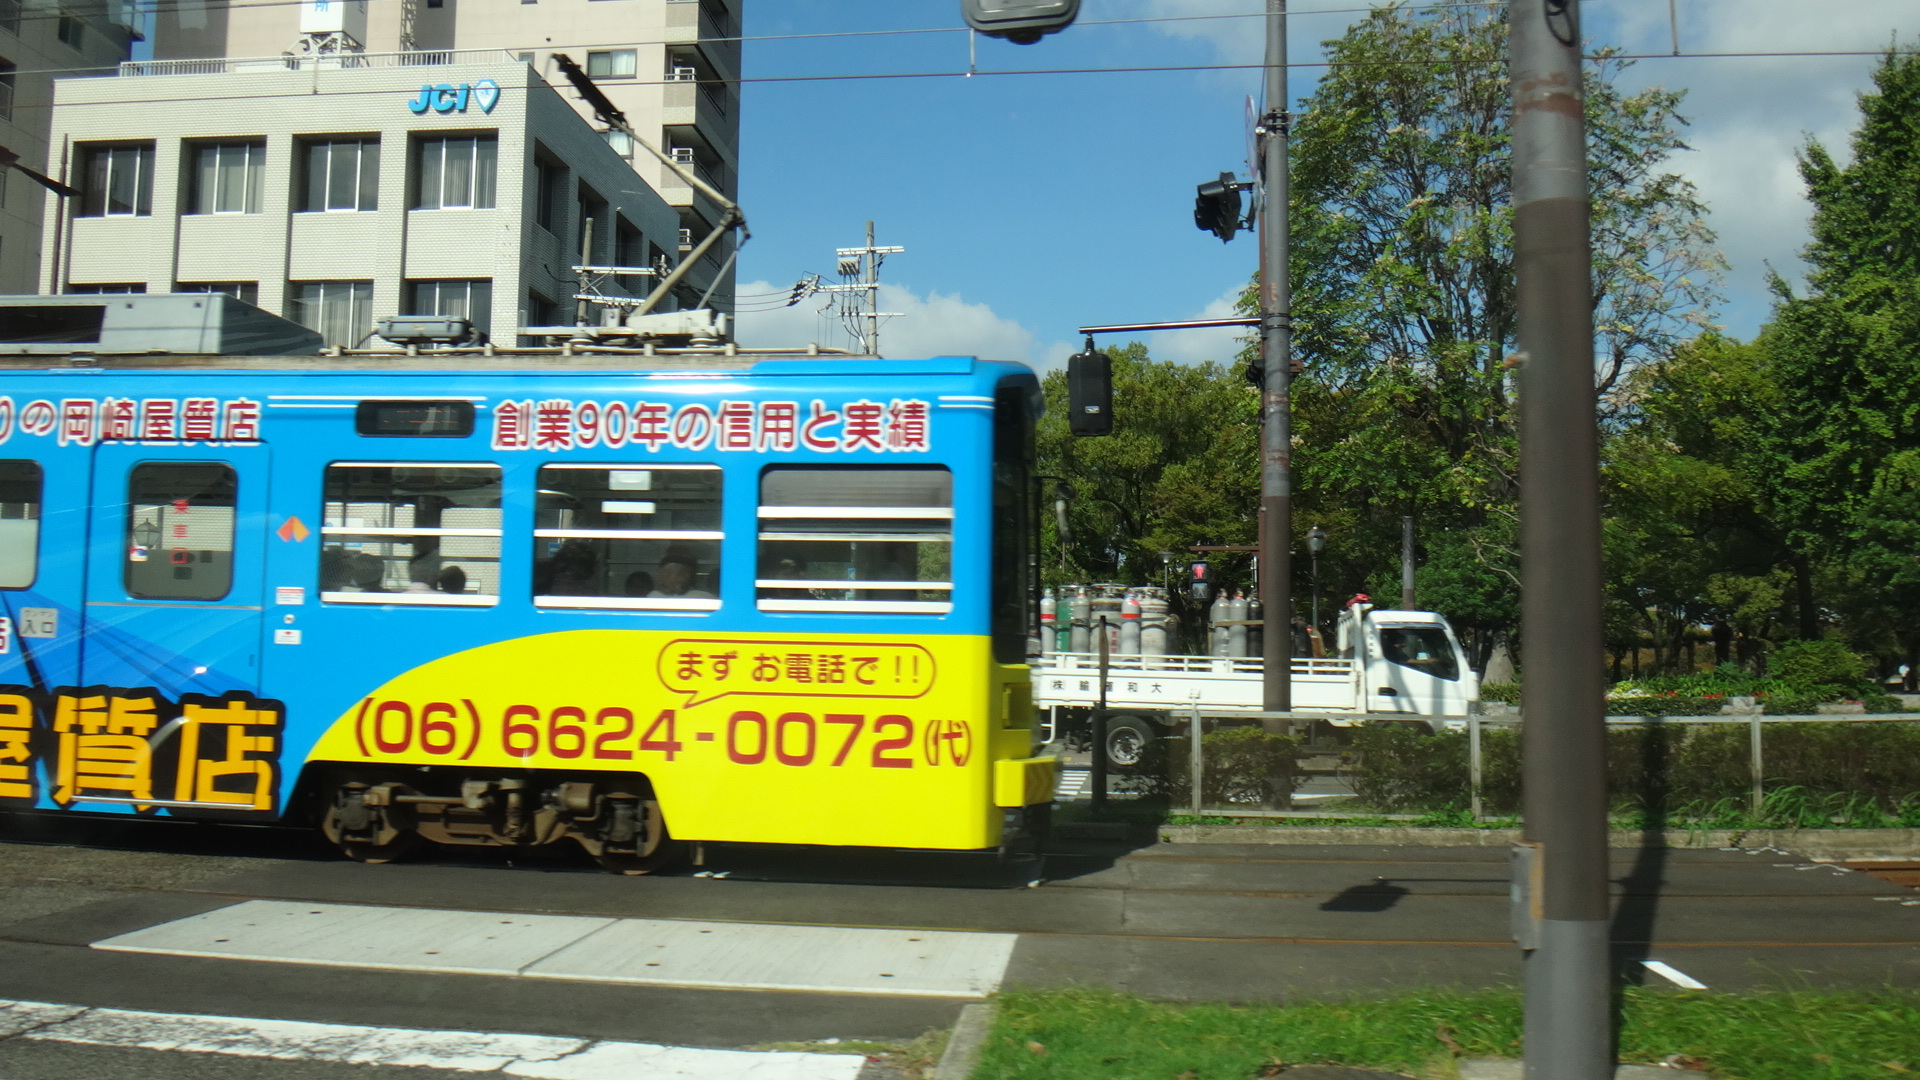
[40,52,687,346]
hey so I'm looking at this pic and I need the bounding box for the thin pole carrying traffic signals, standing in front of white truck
[1260,0,1294,713]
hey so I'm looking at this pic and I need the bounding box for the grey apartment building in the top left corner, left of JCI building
[0,0,134,294]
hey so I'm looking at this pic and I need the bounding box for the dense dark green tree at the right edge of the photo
[1761,52,1920,655]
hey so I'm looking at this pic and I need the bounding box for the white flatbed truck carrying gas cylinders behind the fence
[1033,603,1480,767]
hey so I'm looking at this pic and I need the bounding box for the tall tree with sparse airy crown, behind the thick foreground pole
[1267,4,1720,630]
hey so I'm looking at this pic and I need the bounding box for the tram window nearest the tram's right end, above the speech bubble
[755,465,954,615]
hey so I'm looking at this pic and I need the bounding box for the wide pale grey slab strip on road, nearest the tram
[94,899,1018,997]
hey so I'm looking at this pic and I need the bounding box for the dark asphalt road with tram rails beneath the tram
[0,815,1920,1080]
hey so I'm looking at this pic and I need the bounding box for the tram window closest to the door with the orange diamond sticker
[321,461,499,607]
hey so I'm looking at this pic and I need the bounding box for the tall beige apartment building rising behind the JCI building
[145,0,741,309]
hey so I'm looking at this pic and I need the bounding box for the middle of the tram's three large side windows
[534,463,722,611]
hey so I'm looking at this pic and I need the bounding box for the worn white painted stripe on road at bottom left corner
[0,1001,866,1080]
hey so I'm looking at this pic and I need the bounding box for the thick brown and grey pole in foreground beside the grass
[1507,0,1613,1080]
